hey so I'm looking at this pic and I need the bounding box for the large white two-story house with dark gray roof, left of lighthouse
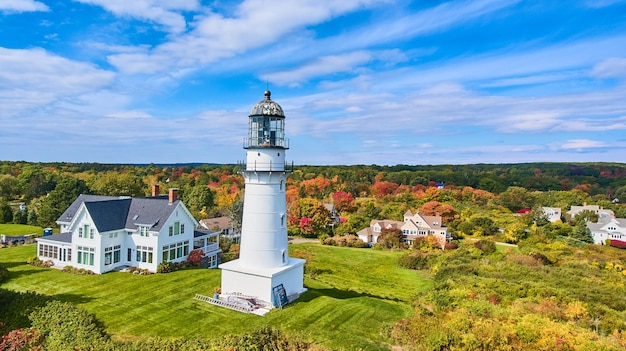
[37,186,221,274]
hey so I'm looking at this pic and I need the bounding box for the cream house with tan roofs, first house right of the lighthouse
[356,210,451,246]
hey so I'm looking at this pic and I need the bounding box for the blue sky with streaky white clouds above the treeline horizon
[0,0,626,165]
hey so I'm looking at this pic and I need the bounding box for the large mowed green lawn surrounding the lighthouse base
[0,244,432,350]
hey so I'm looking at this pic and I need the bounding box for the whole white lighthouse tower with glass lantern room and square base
[220,91,306,306]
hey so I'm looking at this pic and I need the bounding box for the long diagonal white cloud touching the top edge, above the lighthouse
[107,0,388,74]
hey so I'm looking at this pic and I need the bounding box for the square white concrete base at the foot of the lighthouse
[219,257,306,306]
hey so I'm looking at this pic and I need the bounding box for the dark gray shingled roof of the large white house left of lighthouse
[57,195,180,232]
